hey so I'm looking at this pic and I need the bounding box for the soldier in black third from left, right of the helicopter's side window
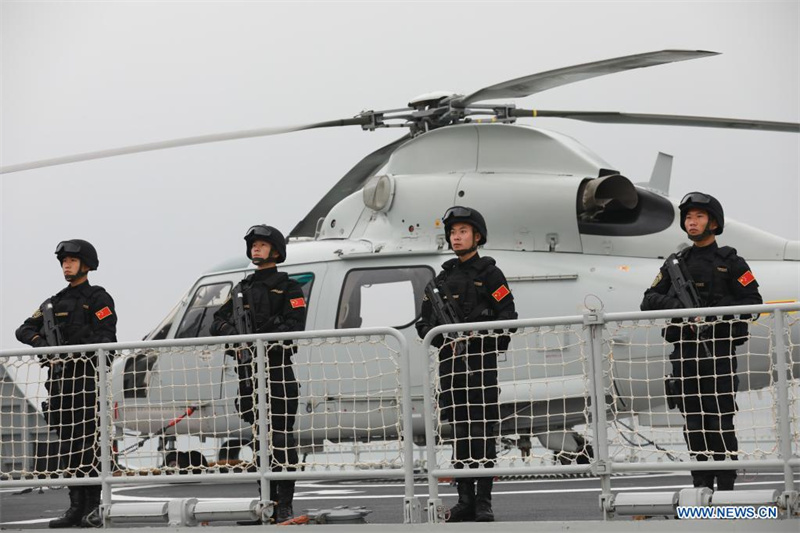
[416,206,517,522]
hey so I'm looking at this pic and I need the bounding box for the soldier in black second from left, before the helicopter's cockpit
[211,224,306,525]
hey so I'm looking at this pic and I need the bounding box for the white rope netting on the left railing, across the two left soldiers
[0,336,403,477]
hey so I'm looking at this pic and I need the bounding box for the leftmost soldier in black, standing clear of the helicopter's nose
[17,239,117,528]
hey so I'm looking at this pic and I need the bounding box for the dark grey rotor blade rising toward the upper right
[453,50,719,107]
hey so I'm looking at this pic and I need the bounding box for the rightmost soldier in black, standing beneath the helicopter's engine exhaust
[641,192,762,490]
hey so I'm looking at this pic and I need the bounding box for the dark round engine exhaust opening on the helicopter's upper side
[576,174,675,237]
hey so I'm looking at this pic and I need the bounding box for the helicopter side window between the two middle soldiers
[336,266,434,329]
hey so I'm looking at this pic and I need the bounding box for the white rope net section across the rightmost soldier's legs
[603,315,798,462]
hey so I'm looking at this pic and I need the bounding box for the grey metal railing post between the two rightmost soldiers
[583,310,611,520]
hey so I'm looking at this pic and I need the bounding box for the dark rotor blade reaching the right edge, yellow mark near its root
[510,108,800,133]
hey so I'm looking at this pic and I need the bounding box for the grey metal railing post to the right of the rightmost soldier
[774,309,797,518]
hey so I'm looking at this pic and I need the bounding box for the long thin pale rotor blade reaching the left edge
[0,114,372,174]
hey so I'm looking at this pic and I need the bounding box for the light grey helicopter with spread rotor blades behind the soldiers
[0,50,800,464]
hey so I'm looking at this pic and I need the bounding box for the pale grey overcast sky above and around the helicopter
[0,1,800,348]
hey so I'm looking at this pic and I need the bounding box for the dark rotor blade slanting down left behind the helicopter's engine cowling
[289,134,411,237]
